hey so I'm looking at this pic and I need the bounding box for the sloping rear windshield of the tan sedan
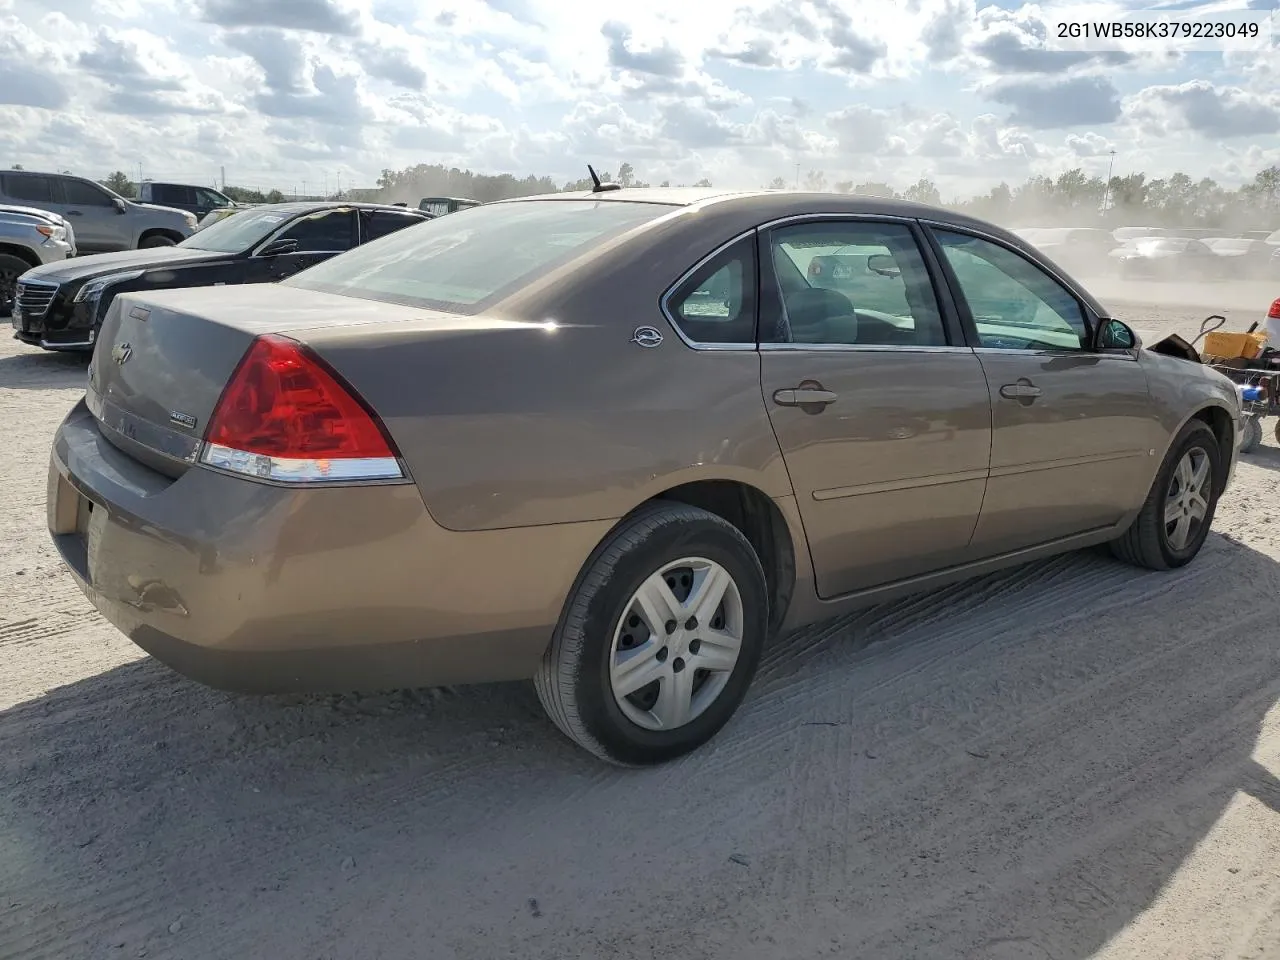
[285,200,676,314]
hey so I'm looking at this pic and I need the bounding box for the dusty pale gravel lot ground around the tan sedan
[0,284,1280,960]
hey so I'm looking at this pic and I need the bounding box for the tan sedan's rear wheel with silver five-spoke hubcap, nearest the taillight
[534,502,769,767]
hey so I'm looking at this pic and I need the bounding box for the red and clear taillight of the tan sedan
[201,334,403,481]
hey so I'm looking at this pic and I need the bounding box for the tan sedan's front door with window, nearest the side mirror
[932,225,1162,556]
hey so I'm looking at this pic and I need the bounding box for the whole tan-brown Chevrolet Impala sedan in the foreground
[49,188,1240,764]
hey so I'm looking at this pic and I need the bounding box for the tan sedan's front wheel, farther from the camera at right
[1111,420,1222,570]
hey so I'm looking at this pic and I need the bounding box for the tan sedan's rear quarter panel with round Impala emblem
[306,206,791,530]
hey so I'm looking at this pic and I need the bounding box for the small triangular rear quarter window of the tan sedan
[667,237,755,344]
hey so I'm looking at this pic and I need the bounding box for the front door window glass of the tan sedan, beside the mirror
[934,230,1089,349]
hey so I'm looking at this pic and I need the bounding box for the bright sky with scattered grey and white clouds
[0,0,1280,197]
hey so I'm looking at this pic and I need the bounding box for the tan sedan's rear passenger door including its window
[759,218,991,598]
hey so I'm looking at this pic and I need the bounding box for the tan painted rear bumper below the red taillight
[47,402,611,692]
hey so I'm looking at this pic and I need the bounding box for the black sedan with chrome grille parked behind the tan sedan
[12,201,431,351]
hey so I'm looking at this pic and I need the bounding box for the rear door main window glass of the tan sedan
[760,220,947,347]
